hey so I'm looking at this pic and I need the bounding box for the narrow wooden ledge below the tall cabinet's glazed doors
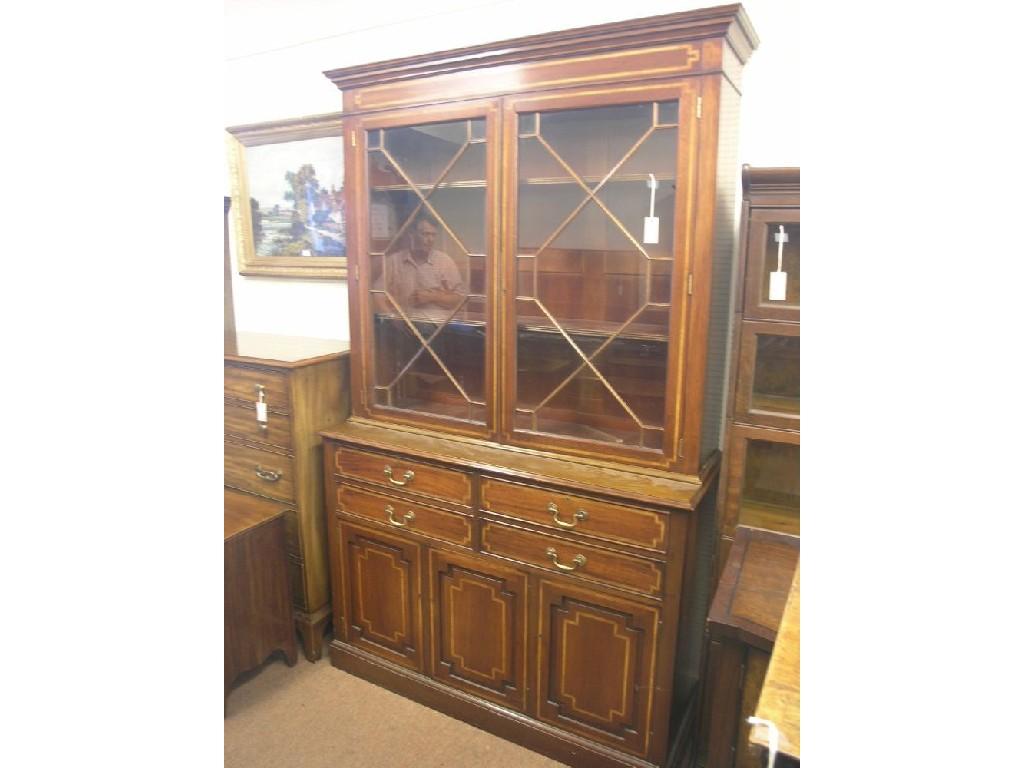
[321,419,717,509]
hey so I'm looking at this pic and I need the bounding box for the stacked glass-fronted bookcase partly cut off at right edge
[718,167,801,568]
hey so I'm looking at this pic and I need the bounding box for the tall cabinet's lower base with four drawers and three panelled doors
[324,419,714,766]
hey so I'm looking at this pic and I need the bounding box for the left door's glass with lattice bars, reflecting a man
[368,120,490,424]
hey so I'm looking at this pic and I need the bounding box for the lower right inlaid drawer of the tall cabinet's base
[480,522,665,595]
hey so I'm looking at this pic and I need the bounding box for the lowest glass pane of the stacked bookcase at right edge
[739,440,800,535]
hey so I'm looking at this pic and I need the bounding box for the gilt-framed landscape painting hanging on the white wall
[226,113,348,279]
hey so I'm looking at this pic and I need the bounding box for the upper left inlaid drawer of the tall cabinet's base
[334,447,472,506]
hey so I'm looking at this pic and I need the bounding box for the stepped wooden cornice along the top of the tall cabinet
[324,4,760,90]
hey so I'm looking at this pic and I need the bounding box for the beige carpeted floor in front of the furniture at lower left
[224,649,562,768]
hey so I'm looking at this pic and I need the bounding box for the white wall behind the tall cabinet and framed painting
[224,0,800,339]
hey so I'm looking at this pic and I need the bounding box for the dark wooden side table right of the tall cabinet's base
[701,525,800,768]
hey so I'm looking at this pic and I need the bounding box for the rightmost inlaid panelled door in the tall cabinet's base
[538,581,659,756]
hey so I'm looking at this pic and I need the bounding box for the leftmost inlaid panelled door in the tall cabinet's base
[338,522,423,671]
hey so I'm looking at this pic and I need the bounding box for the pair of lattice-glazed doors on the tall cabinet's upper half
[351,81,709,473]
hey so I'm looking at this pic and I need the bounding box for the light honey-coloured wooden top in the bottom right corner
[751,563,800,760]
